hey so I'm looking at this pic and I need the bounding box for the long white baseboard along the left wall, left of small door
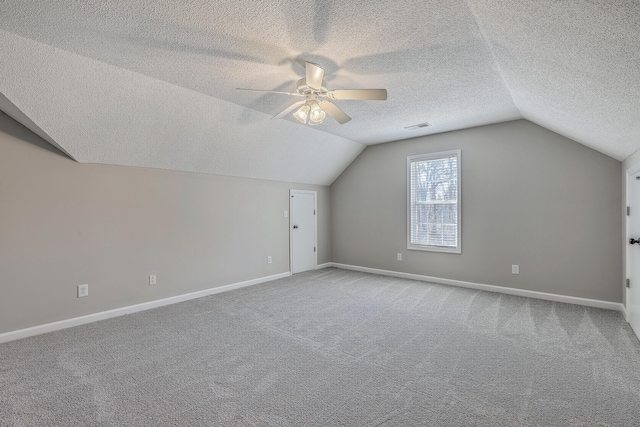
[0,271,291,343]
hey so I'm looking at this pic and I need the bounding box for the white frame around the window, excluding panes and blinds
[407,150,462,254]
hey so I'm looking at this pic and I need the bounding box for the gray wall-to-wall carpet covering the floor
[0,269,640,426]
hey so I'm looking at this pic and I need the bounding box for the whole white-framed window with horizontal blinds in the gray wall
[407,150,461,253]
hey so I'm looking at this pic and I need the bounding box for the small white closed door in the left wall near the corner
[289,190,316,274]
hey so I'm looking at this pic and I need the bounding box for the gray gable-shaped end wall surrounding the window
[331,120,622,302]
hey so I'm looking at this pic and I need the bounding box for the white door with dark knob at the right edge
[627,172,640,338]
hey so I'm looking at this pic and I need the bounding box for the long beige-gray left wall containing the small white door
[0,114,331,333]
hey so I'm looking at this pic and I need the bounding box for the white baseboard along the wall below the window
[331,262,626,312]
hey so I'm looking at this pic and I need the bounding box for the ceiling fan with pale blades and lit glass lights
[238,62,387,125]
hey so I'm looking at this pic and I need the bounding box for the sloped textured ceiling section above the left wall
[0,28,364,185]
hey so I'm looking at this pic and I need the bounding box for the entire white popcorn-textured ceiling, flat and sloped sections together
[0,0,640,185]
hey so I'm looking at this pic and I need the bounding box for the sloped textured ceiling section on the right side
[470,0,640,160]
